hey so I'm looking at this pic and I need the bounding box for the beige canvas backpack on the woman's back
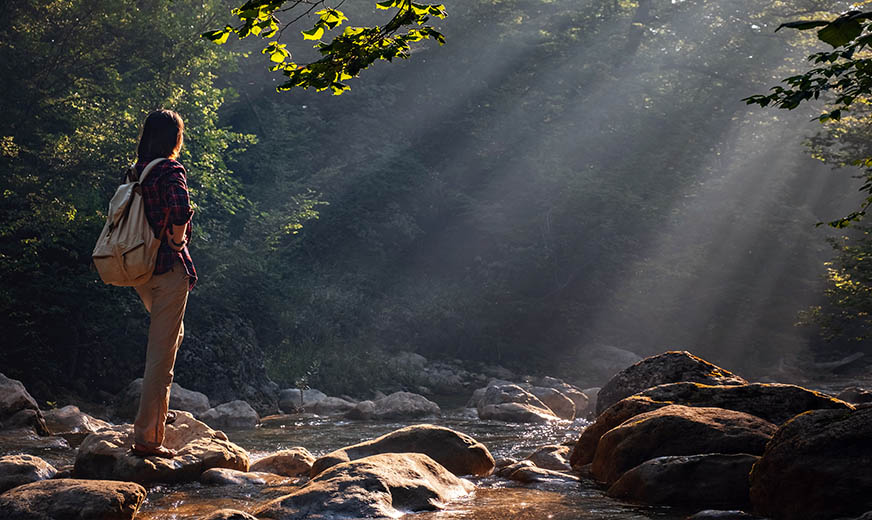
[91,158,168,287]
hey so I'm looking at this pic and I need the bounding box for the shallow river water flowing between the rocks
[0,408,687,520]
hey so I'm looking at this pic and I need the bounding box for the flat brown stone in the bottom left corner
[0,479,146,520]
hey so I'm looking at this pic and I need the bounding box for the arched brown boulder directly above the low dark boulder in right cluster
[591,405,776,484]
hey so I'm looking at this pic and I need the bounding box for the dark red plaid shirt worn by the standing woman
[129,159,197,289]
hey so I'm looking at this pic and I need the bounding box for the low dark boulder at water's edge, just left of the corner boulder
[607,453,759,509]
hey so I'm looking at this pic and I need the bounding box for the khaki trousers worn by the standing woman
[133,262,188,447]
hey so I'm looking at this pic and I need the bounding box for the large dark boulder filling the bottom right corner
[751,408,872,520]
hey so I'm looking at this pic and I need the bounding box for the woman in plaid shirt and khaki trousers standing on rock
[129,110,197,458]
